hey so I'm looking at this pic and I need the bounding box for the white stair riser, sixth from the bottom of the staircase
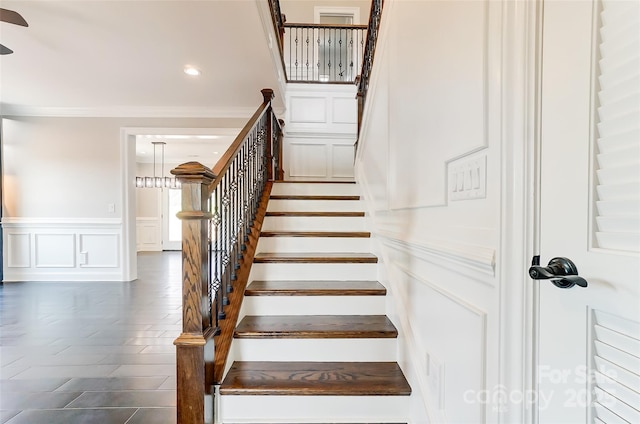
[262,216,367,231]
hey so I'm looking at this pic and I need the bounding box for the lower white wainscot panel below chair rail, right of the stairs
[389,262,487,422]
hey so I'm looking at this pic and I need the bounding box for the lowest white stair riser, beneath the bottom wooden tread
[220,395,410,424]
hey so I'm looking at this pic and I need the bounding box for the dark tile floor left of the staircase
[0,252,182,424]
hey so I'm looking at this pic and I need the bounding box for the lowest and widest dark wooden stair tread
[220,362,411,396]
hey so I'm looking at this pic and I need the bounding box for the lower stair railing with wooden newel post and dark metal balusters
[171,89,283,424]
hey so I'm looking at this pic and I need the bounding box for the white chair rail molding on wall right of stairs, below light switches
[375,231,496,285]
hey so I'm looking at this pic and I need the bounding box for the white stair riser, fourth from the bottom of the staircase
[249,263,378,281]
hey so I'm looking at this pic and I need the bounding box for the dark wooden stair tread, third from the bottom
[244,281,387,296]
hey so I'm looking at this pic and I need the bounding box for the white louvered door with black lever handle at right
[532,0,640,424]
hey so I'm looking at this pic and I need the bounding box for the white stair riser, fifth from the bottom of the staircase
[256,237,371,253]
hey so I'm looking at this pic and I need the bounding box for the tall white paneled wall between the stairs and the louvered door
[356,0,522,423]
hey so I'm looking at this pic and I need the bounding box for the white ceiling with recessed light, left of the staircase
[0,0,282,116]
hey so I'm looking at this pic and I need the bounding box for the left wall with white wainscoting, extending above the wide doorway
[2,117,246,281]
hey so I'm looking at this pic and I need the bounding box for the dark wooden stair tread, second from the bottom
[234,315,398,339]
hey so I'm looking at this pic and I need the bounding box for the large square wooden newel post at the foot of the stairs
[171,162,215,424]
